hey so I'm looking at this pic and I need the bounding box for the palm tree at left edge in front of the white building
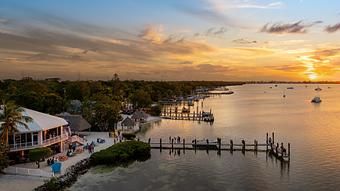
[0,101,32,147]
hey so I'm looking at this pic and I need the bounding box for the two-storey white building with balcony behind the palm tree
[2,108,71,155]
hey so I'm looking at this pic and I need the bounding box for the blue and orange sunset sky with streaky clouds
[0,0,340,81]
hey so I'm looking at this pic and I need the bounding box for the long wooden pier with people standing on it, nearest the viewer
[139,133,291,162]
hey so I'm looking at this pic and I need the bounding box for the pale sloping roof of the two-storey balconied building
[7,108,68,133]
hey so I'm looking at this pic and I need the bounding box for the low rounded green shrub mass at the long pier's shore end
[90,141,151,166]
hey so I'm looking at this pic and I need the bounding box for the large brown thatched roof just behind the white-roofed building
[57,113,91,132]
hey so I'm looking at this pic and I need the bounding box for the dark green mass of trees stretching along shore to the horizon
[0,74,244,131]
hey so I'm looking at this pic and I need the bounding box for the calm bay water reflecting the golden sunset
[71,85,340,191]
